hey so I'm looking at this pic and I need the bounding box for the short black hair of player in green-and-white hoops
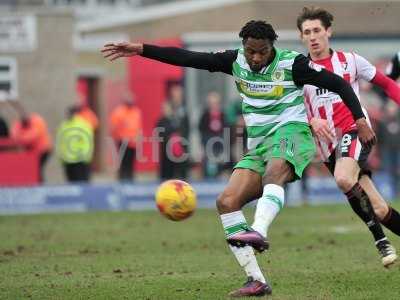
[239,20,278,44]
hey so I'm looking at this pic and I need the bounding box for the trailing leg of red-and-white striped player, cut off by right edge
[358,175,400,236]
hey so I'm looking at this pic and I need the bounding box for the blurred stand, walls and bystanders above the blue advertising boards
[0,0,400,198]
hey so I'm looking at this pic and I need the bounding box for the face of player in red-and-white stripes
[300,20,332,56]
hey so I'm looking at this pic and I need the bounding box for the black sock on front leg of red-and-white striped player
[345,182,386,244]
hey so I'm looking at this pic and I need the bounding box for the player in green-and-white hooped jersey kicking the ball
[102,20,379,297]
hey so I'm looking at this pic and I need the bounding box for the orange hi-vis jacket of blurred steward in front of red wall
[110,105,142,148]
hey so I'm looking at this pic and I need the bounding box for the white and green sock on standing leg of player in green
[221,210,265,283]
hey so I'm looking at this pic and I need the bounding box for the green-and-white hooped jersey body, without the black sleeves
[232,48,308,150]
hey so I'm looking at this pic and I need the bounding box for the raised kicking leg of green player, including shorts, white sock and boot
[231,123,315,247]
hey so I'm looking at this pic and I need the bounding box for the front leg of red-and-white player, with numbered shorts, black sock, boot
[333,132,397,267]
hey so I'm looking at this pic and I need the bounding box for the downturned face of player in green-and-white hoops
[243,38,274,72]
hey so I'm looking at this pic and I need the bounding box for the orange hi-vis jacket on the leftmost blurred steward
[11,113,52,153]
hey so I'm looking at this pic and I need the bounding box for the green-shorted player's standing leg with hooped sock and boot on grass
[217,168,272,296]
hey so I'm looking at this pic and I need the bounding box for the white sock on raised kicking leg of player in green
[251,184,285,237]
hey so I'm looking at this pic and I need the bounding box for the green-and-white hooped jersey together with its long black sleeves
[142,44,365,150]
